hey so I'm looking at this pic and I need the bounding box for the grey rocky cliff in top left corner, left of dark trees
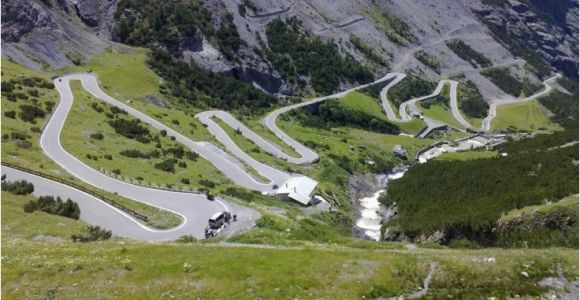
[2,0,117,69]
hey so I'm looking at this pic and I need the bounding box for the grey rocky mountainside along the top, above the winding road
[2,0,578,99]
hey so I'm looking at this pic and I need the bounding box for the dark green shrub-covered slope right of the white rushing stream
[381,132,578,245]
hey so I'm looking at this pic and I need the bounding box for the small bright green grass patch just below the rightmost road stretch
[491,100,561,132]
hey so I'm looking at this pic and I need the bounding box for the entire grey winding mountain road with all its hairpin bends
[2,63,559,241]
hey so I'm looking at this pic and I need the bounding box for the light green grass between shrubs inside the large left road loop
[61,81,228,189]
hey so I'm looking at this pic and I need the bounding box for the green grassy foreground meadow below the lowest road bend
[2,192,578,299]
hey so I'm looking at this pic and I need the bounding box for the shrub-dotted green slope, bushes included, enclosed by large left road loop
[61,81,228,190]
